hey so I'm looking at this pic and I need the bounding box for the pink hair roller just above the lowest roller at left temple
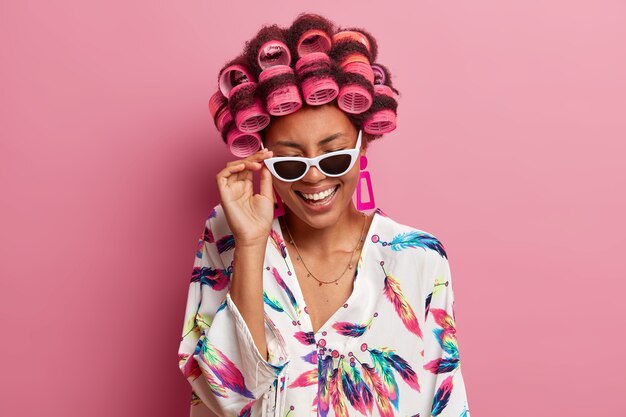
[228,82,270,133]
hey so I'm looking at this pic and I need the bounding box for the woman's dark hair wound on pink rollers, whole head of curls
[209,13,399,157]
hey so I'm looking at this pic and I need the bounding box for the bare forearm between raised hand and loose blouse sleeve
[230,244,267,358]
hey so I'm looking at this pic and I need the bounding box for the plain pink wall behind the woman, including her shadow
[0,0,626,417]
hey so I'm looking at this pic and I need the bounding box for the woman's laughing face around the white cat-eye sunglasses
[265,104,366,229]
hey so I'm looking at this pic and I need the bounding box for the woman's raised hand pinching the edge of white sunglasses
[216,149,274,247]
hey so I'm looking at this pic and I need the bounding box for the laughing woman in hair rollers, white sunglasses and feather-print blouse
[179,15,469,417]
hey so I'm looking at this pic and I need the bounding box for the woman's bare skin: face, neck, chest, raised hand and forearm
[217,104,372,358]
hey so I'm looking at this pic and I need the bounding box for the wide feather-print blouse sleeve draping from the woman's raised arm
[178,214,289,417]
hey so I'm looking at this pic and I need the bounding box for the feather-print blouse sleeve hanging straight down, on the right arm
[421,254,470,417]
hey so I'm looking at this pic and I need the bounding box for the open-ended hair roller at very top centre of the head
[287,14,334,58]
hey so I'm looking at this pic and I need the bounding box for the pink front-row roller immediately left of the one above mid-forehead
[258,65,302,116]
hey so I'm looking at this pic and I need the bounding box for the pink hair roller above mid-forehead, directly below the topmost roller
[296,52,339,106]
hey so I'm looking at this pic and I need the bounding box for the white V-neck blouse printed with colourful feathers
[178,205,470,417]
